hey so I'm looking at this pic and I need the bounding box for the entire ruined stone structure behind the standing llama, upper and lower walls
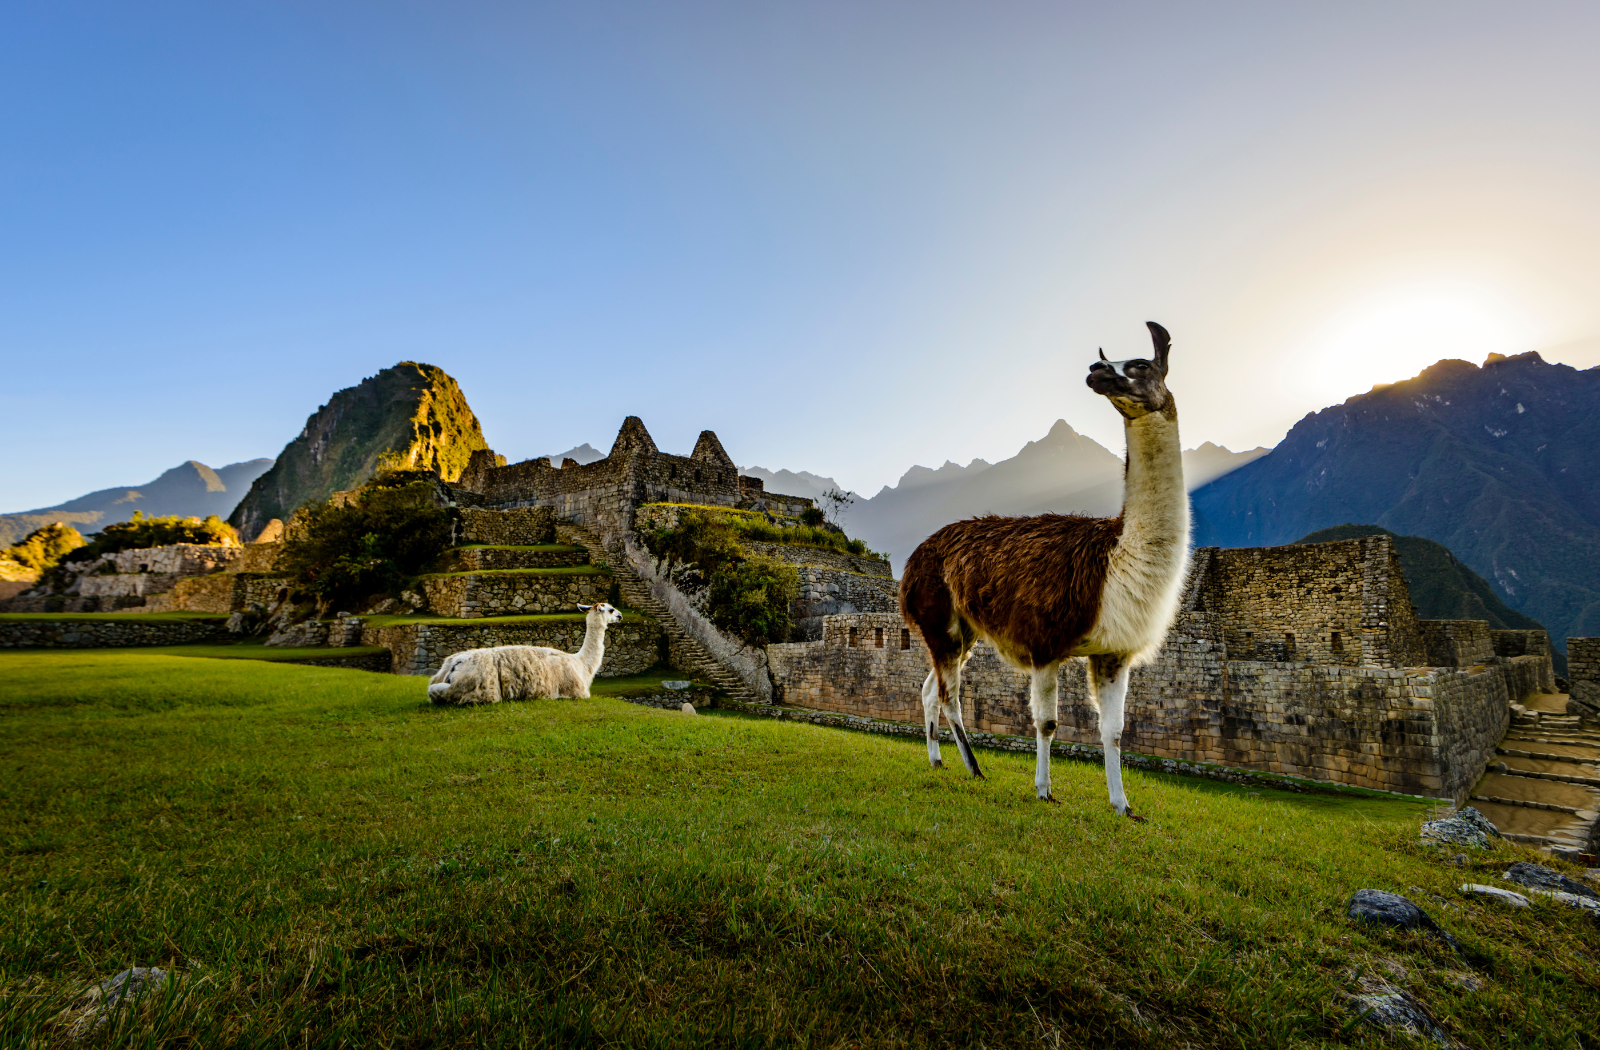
[770,536,1554,799]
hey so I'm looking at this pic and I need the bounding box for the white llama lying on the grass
[427,602,622,704]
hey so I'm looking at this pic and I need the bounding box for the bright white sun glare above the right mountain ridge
[1280,282,1539,405]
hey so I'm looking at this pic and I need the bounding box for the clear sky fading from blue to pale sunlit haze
[9,0,1600,511]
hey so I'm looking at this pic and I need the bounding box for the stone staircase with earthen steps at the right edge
[1472,693,1600,856]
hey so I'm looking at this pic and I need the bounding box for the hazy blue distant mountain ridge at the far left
[0,459,272,546]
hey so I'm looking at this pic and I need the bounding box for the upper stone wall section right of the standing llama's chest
[1195,536,1427,667]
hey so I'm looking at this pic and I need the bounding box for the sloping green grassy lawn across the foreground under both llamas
[0,650,1600,1047]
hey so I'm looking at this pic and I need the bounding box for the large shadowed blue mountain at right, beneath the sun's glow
[1194,354,1600,650]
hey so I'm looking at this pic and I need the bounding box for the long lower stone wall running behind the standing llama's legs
[768,601,1529,797]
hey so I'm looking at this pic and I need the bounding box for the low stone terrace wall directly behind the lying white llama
[362,618,664,677]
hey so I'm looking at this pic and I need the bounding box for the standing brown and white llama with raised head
[901,322,1189,820]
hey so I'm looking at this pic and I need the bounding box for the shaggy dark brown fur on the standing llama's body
[901,514,1122,675]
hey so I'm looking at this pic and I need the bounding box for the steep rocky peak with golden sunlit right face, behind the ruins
[229,362,488,541]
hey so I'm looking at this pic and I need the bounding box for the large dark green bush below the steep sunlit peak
[280,482,451,613]
